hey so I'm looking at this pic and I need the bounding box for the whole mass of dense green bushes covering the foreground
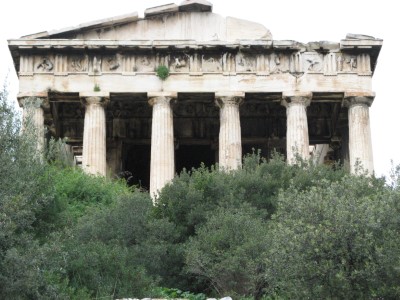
[0,91,400,299]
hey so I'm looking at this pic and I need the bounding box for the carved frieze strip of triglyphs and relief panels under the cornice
[20,50,372,77]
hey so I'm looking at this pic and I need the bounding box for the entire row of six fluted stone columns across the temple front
[18,92,374,198]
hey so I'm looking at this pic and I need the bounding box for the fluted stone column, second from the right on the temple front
[282,92,312,164]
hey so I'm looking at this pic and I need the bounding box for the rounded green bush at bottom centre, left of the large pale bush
[186,204,268,298]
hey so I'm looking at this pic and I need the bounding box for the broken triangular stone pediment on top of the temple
[23,0,272,41]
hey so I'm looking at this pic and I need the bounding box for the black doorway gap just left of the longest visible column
[123,145,150,190]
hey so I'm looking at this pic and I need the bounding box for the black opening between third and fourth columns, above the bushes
[175,145,215,174]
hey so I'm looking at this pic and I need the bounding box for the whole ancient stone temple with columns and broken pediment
[9,0,382,195]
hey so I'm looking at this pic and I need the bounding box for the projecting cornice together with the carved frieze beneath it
[9,39,382,77]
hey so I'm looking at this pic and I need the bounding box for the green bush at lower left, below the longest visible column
[62,191,177,297]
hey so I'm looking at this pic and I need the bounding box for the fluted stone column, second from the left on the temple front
[80,93,109,176]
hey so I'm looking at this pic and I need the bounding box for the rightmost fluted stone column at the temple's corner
[344,92,375,174]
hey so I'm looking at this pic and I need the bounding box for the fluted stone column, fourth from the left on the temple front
[215,92,244,170]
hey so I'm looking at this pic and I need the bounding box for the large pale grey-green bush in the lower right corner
[265,176,400,299]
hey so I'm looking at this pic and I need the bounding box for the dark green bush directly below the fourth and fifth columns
[156,153,345,240]
